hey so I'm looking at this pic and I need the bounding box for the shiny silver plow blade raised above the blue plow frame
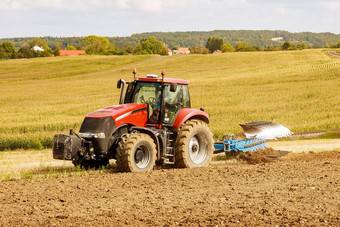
[240,121,293,140]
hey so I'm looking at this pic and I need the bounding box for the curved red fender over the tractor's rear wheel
[172,108,209,128]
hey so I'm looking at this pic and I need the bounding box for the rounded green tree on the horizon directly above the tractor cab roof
[135,36,168,55]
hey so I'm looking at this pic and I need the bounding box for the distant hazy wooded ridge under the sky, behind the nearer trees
[0,30,340,50]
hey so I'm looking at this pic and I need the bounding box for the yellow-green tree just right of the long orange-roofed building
[82,35,109,54]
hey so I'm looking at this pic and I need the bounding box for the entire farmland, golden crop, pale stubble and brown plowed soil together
[0,50,340,226]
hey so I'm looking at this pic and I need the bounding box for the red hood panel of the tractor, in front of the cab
[86,103,148,127]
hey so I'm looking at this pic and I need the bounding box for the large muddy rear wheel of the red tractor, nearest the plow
[175,120,214,168]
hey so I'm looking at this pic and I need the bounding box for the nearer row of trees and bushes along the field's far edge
[0,35,340,59]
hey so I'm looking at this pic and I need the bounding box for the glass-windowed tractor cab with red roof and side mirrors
[117,72,191,126]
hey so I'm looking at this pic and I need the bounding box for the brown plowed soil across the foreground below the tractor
[0,151,340,226]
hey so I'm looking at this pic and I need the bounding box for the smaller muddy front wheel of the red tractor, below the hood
[116,133,157,172]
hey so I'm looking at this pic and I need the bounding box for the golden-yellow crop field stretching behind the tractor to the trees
[0,50,340,150]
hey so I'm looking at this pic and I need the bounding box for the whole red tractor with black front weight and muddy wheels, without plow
[53,70,214,172]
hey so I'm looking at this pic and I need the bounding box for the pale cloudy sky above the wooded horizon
[0,0,340,38]
